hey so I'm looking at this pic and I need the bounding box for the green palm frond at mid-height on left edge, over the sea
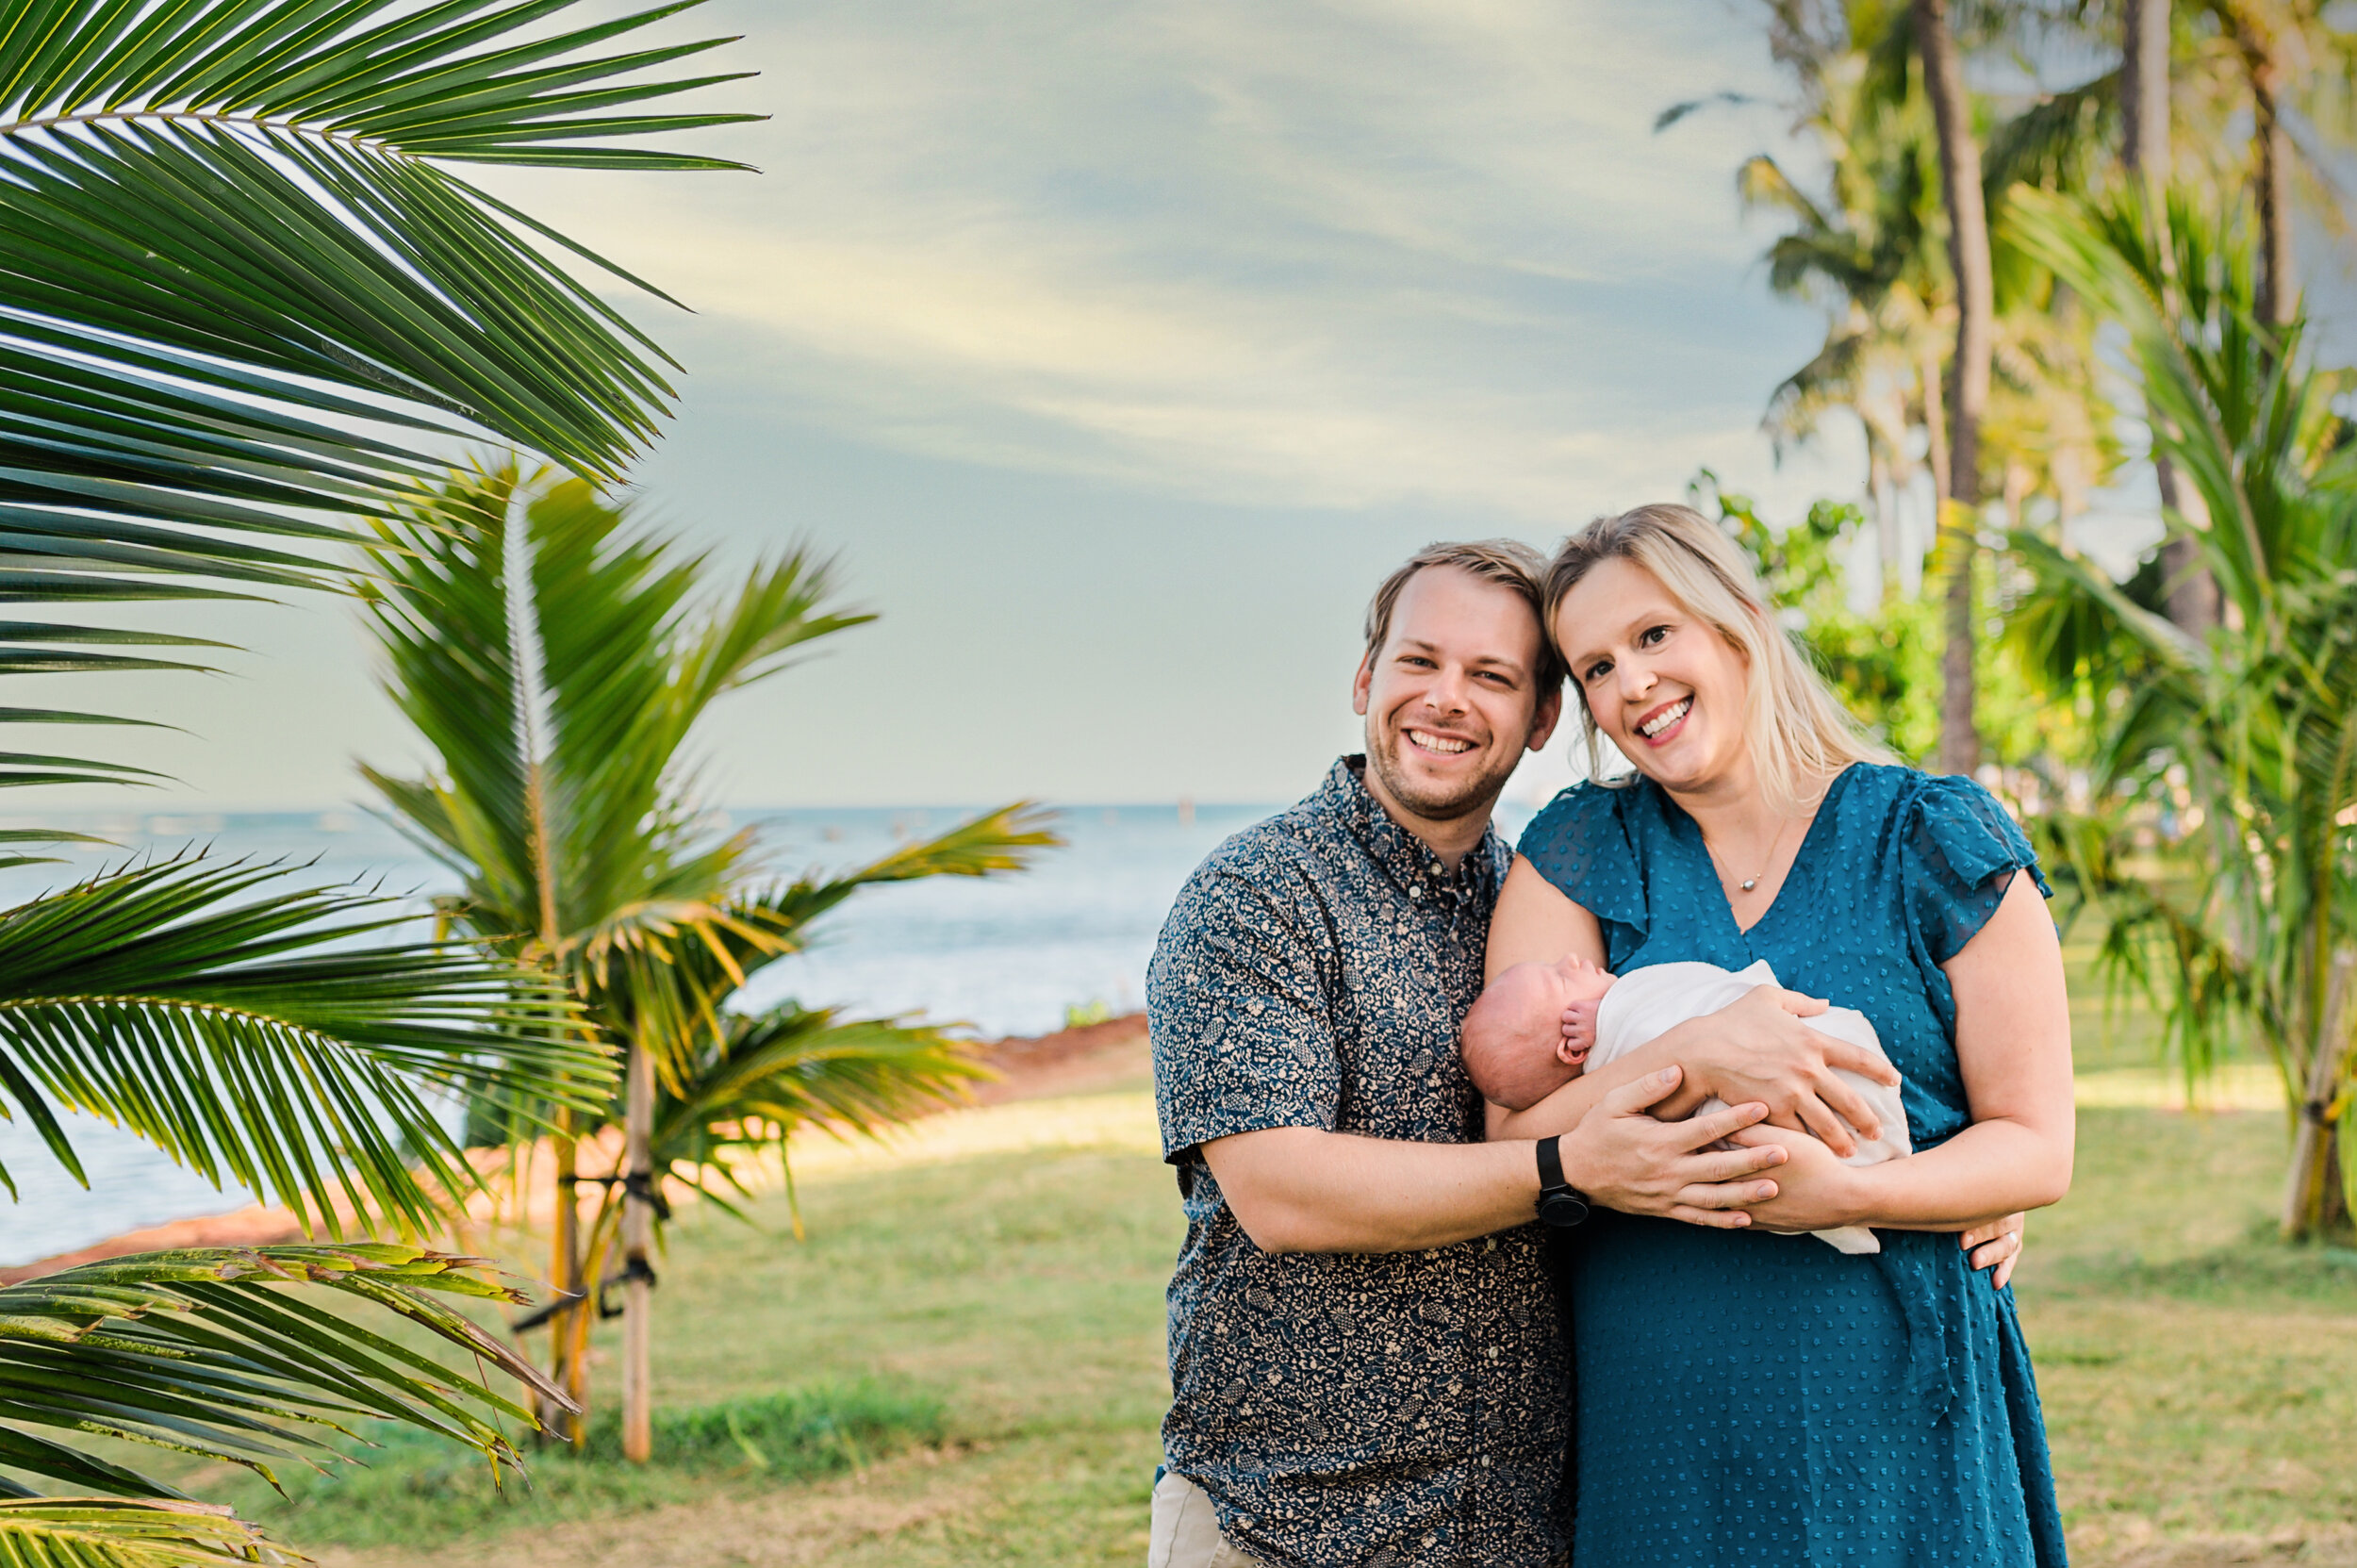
[0,858,611,1233]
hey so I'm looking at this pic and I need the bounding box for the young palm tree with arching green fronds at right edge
[2025,191,2357,1238]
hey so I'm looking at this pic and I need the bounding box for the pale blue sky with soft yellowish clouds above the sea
[19,0,2263,811]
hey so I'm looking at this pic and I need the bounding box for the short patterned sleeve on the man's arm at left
[1146,870,1342,1163]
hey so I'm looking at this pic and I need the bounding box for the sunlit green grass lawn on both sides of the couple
[212,1070,2357,1568]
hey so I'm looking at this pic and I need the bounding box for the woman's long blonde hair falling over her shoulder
[1546,503,1898,814]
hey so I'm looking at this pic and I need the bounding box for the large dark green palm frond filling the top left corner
[0,0,757,783]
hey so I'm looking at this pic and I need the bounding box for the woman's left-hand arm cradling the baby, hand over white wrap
[1488,856,1898,1153]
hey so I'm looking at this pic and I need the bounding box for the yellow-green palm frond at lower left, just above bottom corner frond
[0,1243,566,1499]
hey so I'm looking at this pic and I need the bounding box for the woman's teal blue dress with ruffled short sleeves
[1521,764,2065,1568]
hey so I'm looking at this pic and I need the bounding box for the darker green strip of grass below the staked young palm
[222,1381,943,1549]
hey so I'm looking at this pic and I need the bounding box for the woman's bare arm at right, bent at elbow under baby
[1735,872,2077,1230]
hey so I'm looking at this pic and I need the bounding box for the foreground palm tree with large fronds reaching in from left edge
[0,0,745,1565]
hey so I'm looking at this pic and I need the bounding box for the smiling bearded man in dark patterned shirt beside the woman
[1146,540,1785,1568]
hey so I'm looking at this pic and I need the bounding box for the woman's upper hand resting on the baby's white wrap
[1662,985,1900,1158]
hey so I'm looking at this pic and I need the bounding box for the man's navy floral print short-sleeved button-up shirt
[1146,757,1570,1568]
